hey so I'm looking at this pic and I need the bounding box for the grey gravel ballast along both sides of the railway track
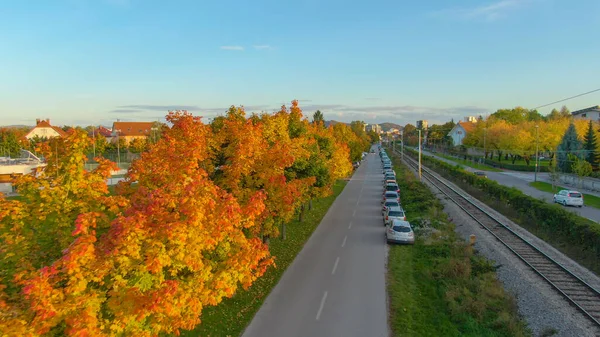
[404,159,600,336]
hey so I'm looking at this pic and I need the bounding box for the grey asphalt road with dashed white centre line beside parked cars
[242,149,389,337]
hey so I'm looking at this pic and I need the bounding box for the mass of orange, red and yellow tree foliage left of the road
[0,101,350,336]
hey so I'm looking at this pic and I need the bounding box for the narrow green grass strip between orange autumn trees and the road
[175,180,346,337]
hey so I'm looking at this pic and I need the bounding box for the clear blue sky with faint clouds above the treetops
[0,0,600,125]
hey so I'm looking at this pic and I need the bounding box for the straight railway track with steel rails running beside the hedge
[397,148,600,326]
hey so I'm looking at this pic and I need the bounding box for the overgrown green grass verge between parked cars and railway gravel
[387,153,531,336]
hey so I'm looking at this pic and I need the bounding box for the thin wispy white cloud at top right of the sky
[433,0,531,21]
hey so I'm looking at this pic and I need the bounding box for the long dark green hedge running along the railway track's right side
[405,148,600,260]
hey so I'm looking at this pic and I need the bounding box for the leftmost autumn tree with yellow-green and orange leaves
[0,129,127,336]
